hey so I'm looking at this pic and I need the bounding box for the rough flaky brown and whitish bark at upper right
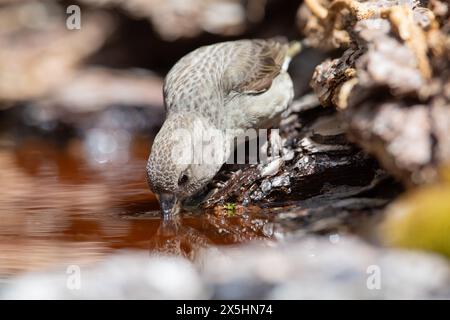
[299,0,450,186]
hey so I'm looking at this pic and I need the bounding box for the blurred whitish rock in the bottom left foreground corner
[0,252,209,300]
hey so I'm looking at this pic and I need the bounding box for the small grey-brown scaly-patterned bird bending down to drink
[146,37,301,217]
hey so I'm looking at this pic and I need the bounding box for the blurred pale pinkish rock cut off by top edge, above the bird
[78,0,266,41]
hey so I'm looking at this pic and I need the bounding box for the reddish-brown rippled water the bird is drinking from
[0,135,266,277]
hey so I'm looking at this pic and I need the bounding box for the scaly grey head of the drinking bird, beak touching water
[147,114,225,217]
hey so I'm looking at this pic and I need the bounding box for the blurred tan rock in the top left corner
[0,1,114,102]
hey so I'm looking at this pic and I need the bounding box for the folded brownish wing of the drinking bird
[226,38,289,94]
